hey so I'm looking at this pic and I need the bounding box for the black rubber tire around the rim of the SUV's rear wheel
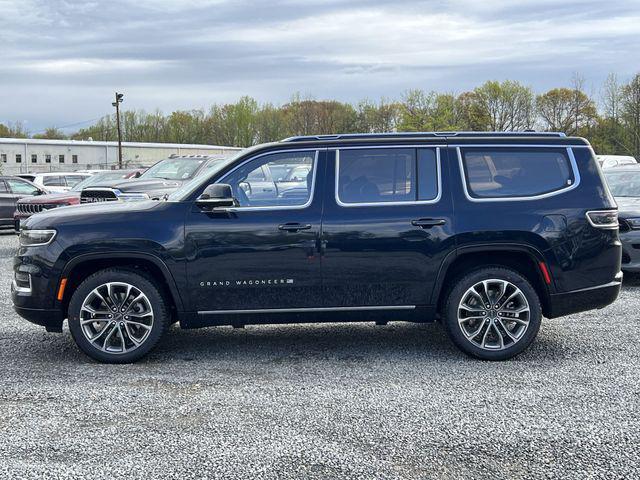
[444,267,542,360]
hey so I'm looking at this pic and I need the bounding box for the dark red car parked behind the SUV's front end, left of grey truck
[13,169,145,233]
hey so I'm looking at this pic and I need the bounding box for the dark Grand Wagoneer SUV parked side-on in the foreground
[12,133,622,363]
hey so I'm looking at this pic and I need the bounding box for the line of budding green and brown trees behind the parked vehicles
[0,73,640,159]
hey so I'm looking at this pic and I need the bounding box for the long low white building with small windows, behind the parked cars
[0,138,240,175]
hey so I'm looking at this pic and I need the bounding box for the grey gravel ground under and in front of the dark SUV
[0,235,640,479]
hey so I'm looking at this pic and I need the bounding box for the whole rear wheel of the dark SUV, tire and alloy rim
[443,267,542,360]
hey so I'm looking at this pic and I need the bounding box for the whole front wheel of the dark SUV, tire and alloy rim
[69,268,170,363]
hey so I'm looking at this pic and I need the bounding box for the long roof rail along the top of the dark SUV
[281,131,566,142]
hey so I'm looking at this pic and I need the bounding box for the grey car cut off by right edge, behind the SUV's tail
[605,164,640,273]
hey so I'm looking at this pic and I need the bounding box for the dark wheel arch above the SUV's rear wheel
[431,244,555,315]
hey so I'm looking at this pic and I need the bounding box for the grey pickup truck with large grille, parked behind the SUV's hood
[80,155,234,203]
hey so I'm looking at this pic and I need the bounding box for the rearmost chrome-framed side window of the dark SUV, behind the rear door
[461,148,575,198]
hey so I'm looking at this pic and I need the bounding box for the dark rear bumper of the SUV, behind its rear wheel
[545,272,622,318]
